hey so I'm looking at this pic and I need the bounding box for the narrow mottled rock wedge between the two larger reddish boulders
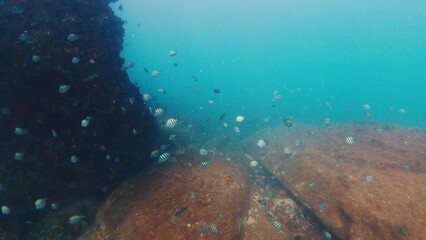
[242,158,323,240]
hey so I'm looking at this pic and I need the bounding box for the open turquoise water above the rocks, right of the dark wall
[112,0,426,132]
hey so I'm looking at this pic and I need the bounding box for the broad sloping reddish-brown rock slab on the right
[246,123,426,240]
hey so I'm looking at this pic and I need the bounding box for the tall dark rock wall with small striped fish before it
[0,0,157,236]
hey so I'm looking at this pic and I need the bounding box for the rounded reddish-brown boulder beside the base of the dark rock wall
[79,150,249,240]
